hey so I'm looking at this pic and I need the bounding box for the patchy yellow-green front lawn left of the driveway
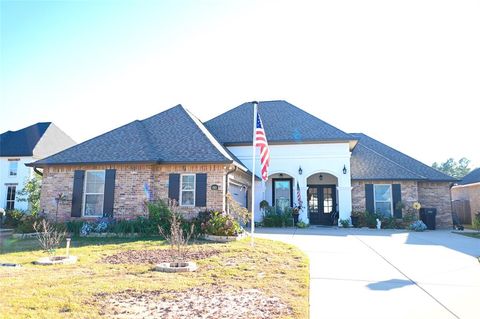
[0,238,309,318]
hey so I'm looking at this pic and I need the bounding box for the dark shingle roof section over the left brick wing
[31,105,237,166]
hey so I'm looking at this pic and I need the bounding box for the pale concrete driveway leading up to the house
[256,227,480,319]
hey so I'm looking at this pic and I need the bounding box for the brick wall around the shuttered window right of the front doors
[352,180,418,211]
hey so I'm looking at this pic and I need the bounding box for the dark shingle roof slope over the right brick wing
[350,133,456,182]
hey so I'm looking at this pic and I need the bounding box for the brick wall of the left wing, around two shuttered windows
[40,164,228,220]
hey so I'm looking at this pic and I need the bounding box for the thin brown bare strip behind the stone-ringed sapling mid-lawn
[102,249,220,264]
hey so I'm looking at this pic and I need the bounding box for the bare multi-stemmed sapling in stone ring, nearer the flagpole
[158,200,195,262]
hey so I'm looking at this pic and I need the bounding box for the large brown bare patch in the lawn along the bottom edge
[97,286,292,319]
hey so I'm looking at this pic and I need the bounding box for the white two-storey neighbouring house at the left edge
[0,122,75,210]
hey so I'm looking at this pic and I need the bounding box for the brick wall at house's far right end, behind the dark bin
[418,182,452,228]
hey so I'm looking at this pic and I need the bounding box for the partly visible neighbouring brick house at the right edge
[451,167,480,224]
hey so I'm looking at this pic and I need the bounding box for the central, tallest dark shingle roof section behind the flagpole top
[205,101,354,145]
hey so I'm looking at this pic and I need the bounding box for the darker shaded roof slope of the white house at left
[0,122,51,156]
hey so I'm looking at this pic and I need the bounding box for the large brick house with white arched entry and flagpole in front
[30,101,455,227]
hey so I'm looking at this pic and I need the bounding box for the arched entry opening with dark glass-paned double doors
[307,173,338,226]
